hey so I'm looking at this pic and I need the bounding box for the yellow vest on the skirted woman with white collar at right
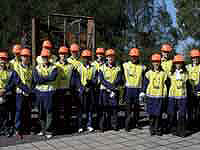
[169,73,188,98]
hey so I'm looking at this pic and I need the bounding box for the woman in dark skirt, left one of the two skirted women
[143,54,167,135]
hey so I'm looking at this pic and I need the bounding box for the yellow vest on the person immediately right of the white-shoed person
[100,64,121,89]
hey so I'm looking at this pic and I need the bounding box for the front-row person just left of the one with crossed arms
[15,48,32,136]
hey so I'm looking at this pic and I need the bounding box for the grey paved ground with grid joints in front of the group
[0,127,200,150]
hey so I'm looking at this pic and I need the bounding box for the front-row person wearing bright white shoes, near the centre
[76,50,97,133]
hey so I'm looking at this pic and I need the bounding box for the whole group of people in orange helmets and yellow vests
[0,40,200,139]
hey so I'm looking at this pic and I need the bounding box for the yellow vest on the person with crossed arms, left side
[36,65,56,92]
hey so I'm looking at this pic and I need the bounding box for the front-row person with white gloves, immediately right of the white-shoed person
[99,49,122,131]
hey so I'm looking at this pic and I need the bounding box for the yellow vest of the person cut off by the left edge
[0,70,12,89]
